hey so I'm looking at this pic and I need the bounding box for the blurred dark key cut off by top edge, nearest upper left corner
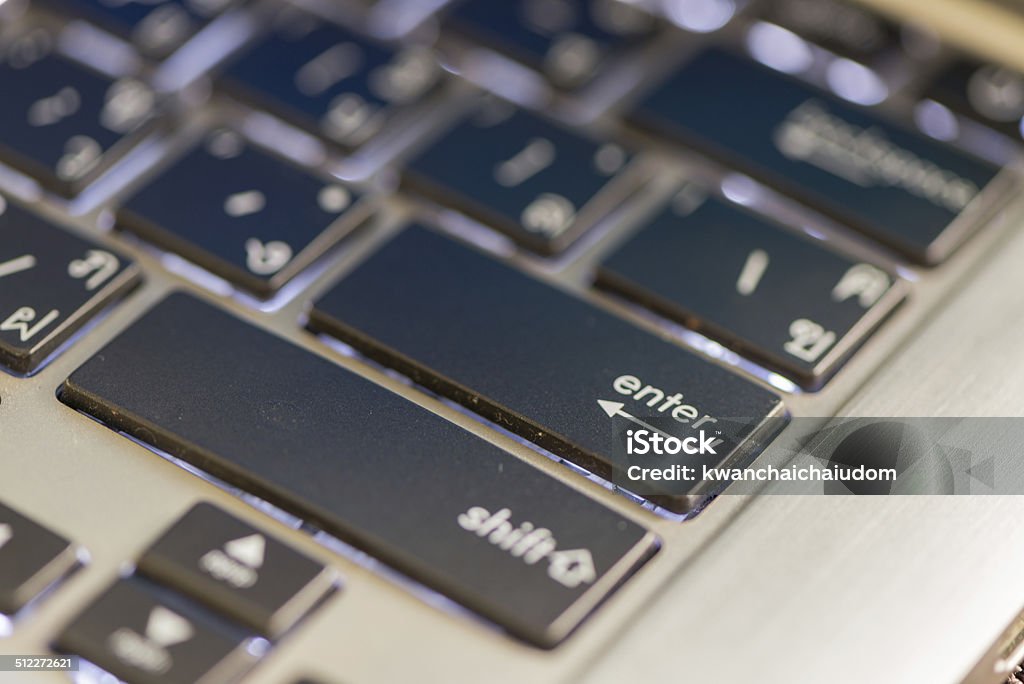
[46,0,236,57]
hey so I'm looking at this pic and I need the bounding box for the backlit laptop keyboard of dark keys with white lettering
[0,0,1024,671]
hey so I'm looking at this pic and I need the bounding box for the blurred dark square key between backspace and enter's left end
[409,102,630,254]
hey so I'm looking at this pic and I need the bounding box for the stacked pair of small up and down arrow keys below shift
[54,503,337,684]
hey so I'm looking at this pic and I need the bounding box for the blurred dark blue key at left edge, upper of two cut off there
[0,31,154,196]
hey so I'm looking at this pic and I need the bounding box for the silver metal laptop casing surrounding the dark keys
[0,3,1024,684]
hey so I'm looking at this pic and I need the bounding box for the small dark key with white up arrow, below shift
[138,504,336,637]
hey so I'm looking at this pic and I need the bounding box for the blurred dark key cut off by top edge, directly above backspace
[761,0,900,65]
